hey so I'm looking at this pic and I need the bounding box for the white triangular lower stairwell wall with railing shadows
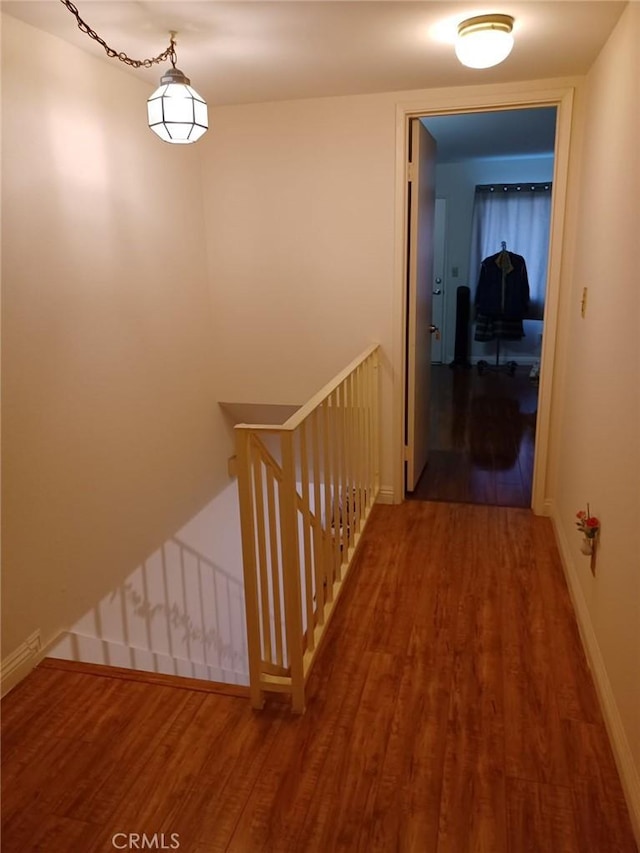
[49,482,249,684]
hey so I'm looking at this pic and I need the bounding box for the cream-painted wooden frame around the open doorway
[392,85,574,515]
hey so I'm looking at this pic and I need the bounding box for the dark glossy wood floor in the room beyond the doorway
[410,365,538,507]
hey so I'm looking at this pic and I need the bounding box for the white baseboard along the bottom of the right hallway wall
[549,504,640,847]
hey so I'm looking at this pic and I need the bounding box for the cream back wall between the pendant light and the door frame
[203,91,395,492]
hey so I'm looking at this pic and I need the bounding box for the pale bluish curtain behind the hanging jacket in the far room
[469,182,551,320]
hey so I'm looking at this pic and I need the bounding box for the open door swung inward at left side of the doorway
[405,119,436,492]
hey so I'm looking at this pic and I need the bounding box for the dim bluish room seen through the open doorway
[406,107,556,507]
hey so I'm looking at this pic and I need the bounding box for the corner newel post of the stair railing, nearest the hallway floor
[280,430,305,714]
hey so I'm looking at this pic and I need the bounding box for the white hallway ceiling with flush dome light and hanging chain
[0,0,626,105]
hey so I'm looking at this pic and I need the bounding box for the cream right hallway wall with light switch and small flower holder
[550,3,640,838]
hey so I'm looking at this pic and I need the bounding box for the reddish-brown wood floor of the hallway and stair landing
[2,501,636,853]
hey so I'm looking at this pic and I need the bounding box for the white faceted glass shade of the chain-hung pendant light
[147,67,209,144]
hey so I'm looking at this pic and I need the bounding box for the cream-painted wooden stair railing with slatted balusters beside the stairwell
[235,344,380,713]
